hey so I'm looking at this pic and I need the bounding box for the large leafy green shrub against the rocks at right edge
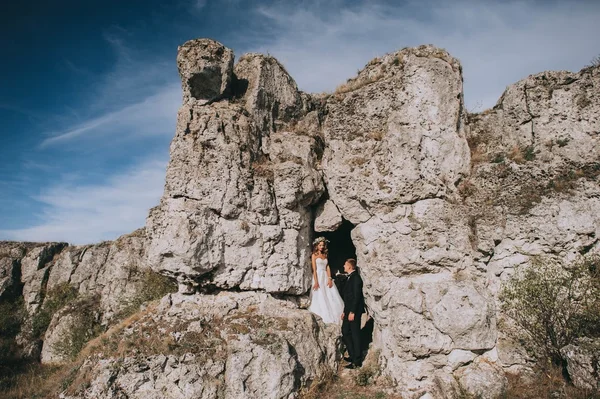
[500,256,600,365]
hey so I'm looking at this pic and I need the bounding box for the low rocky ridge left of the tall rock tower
[0,229,154,363]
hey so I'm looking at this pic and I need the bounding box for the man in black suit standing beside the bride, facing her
[342,259,365,369]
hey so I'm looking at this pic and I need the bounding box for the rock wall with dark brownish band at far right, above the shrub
[460,68,600,378]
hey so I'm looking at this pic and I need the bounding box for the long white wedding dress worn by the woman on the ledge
[308,258,344,324]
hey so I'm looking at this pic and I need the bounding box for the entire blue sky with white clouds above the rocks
[0,0,600,244]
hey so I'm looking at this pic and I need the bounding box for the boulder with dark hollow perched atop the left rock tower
[177,39,233,104]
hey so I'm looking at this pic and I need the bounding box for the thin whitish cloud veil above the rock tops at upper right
[252,0,600,108]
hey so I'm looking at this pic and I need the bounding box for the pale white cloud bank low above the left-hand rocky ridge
[0,160,166,244]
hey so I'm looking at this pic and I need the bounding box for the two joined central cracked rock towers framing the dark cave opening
[147,40,496,397]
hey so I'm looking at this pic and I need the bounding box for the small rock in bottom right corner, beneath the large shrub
[560,338,600,391]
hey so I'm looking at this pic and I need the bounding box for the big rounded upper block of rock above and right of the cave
[323,46,469,224]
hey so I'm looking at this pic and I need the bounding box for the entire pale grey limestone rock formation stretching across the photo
[0,39,600,399]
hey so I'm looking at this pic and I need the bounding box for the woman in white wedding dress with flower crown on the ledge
[308,237,344,324]
